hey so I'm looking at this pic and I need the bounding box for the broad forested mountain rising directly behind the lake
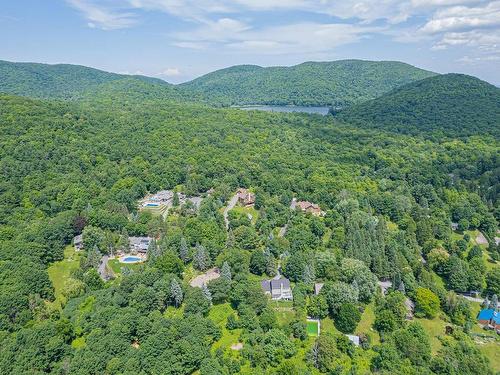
[181,60,435,107]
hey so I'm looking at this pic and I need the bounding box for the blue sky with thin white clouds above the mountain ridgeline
[0,0,500,85]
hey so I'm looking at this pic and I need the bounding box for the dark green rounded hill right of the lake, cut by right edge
[337,74,500,137]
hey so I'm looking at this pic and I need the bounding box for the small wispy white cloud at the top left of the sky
[66,0,137,30]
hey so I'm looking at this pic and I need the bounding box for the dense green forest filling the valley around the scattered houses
[0,60,500,375]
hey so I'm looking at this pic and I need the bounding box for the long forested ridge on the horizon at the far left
[0,60,180,99]
